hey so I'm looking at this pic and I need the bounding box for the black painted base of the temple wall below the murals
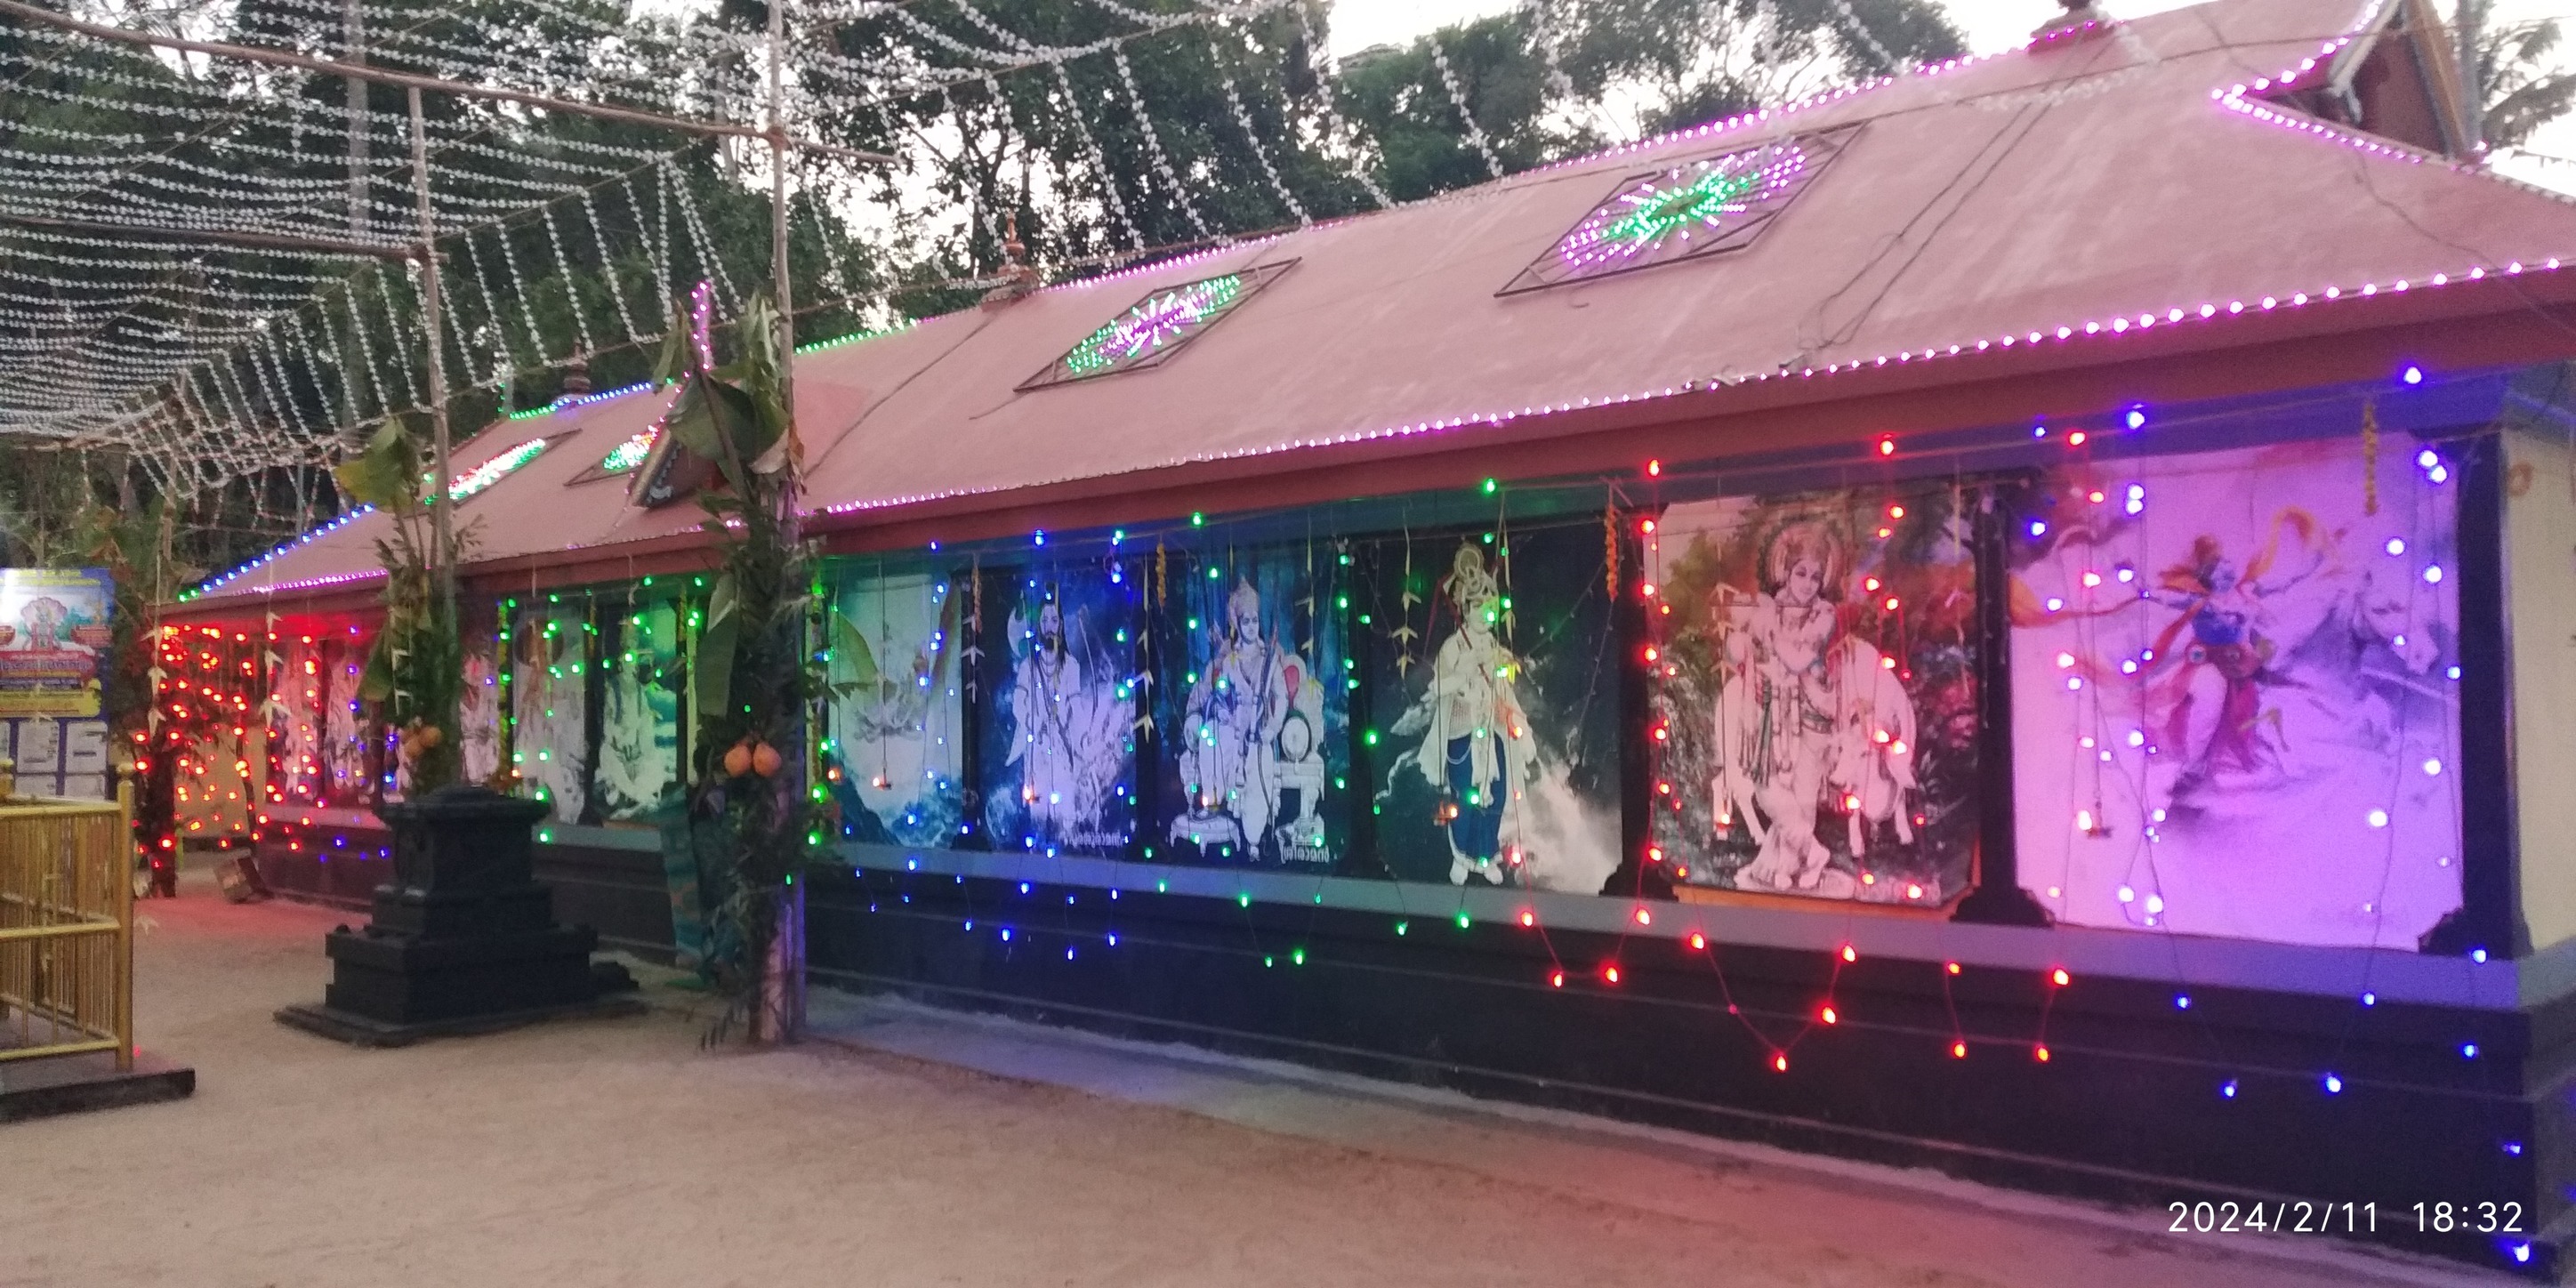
[809,868,2576,1277]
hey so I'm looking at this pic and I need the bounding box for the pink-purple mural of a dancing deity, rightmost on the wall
[2012,433,2460,948]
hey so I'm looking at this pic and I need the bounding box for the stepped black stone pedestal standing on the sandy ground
[278,783,639,1046]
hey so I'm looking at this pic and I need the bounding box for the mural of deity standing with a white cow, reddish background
[1648,492,1978,906]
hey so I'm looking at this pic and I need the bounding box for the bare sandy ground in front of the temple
[0,881,2504,1288]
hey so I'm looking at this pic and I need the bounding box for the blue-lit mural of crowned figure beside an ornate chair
[1164,551,1348,865]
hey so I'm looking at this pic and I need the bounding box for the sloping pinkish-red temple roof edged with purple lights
[190,0,2576,603]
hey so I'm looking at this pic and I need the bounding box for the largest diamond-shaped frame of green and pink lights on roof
[1494,126,1860,296]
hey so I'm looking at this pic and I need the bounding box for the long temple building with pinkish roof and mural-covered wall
[157,0,2576,1276]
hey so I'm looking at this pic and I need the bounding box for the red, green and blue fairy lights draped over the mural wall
[162,358,2527,1283]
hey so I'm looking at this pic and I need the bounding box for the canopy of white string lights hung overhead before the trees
[0,0,1936,492]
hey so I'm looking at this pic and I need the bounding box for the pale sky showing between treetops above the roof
[1332,0,2576,196]
